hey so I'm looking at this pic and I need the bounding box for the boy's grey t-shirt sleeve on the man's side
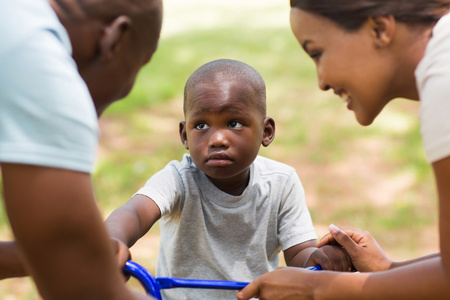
[135,161,184,216]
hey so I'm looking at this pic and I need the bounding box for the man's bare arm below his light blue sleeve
[2,164,153,300]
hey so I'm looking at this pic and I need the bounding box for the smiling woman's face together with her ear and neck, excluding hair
[291,5,431,125]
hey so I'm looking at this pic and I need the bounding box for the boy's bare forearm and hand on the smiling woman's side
[284,240,352,271]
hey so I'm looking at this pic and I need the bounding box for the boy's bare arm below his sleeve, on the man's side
[105,195,161,247]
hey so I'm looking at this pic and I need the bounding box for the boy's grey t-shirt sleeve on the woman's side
[278,171,317,251]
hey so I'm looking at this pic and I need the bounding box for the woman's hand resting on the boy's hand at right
[317,225,392,272]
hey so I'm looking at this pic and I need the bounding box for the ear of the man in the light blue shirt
[100,15,131,60]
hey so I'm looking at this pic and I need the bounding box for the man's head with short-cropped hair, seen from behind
[50,0,162,114]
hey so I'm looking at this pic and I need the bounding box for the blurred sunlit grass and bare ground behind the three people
[0,0,438,300]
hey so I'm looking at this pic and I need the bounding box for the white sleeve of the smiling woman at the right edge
[416,15,450,163]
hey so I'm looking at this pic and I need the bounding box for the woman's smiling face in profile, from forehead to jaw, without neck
[291,8,394,125]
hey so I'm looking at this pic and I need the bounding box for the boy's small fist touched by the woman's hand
[305,245,352,272]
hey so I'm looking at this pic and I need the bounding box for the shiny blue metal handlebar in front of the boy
[124,260,322,300]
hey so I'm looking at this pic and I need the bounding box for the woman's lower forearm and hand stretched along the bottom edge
[237,253,450,300]
